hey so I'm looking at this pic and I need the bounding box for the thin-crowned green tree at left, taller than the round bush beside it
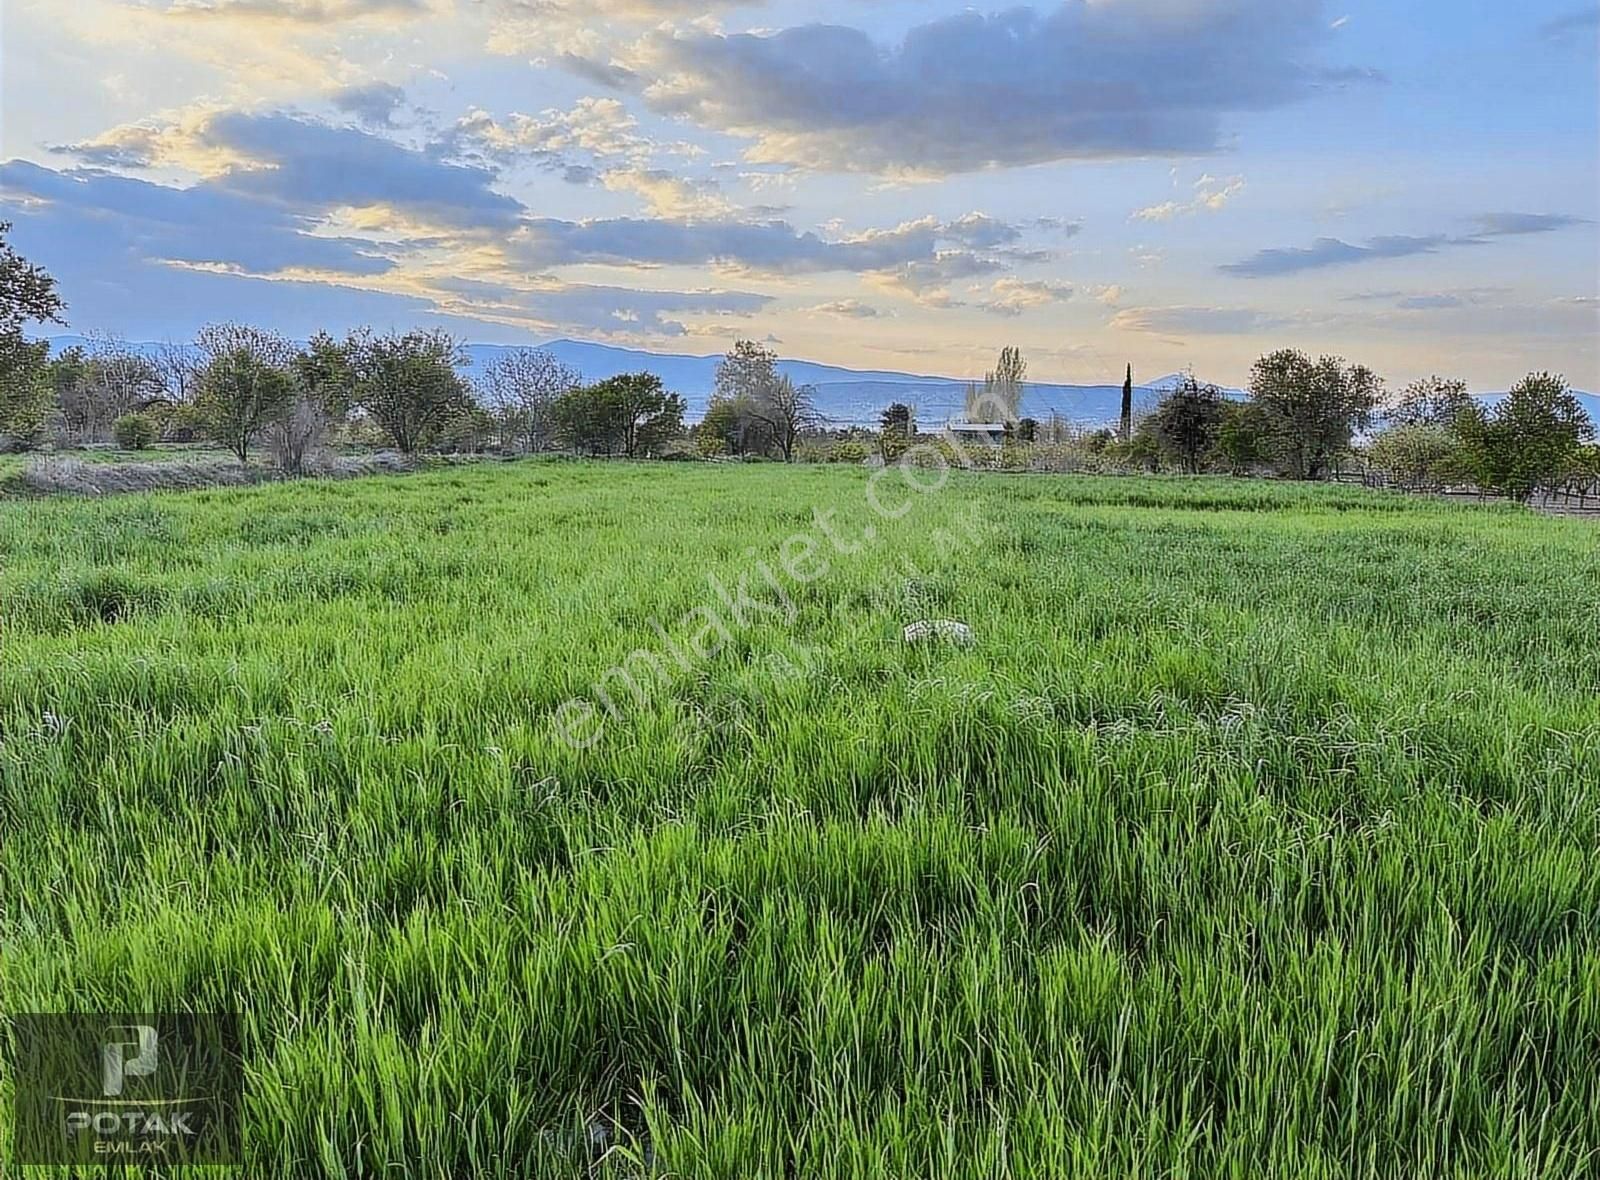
[195,323,296,462]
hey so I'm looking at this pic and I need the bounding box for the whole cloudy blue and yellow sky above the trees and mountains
[0,0,1600,390]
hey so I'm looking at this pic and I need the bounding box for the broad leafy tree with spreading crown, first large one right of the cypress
[1250,349,1382,480]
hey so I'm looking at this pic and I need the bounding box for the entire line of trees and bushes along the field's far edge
[0,222,1600,499]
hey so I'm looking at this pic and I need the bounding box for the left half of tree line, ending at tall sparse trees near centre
[0,224,821,472]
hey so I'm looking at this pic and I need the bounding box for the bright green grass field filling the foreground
[0,462,1600,1180]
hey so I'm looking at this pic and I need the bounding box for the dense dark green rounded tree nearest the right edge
[1458,373,1594,500]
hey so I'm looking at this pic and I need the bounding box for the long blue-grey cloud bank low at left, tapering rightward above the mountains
[0,151,773,339]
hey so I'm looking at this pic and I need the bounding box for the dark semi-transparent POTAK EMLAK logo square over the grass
[11,1012,242,1164]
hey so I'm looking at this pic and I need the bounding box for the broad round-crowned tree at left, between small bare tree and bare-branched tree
[344,328,472,454]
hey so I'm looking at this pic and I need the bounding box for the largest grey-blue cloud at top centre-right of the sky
[604,0,1356,176]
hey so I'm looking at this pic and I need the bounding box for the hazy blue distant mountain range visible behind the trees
[40,336,1600,429]
